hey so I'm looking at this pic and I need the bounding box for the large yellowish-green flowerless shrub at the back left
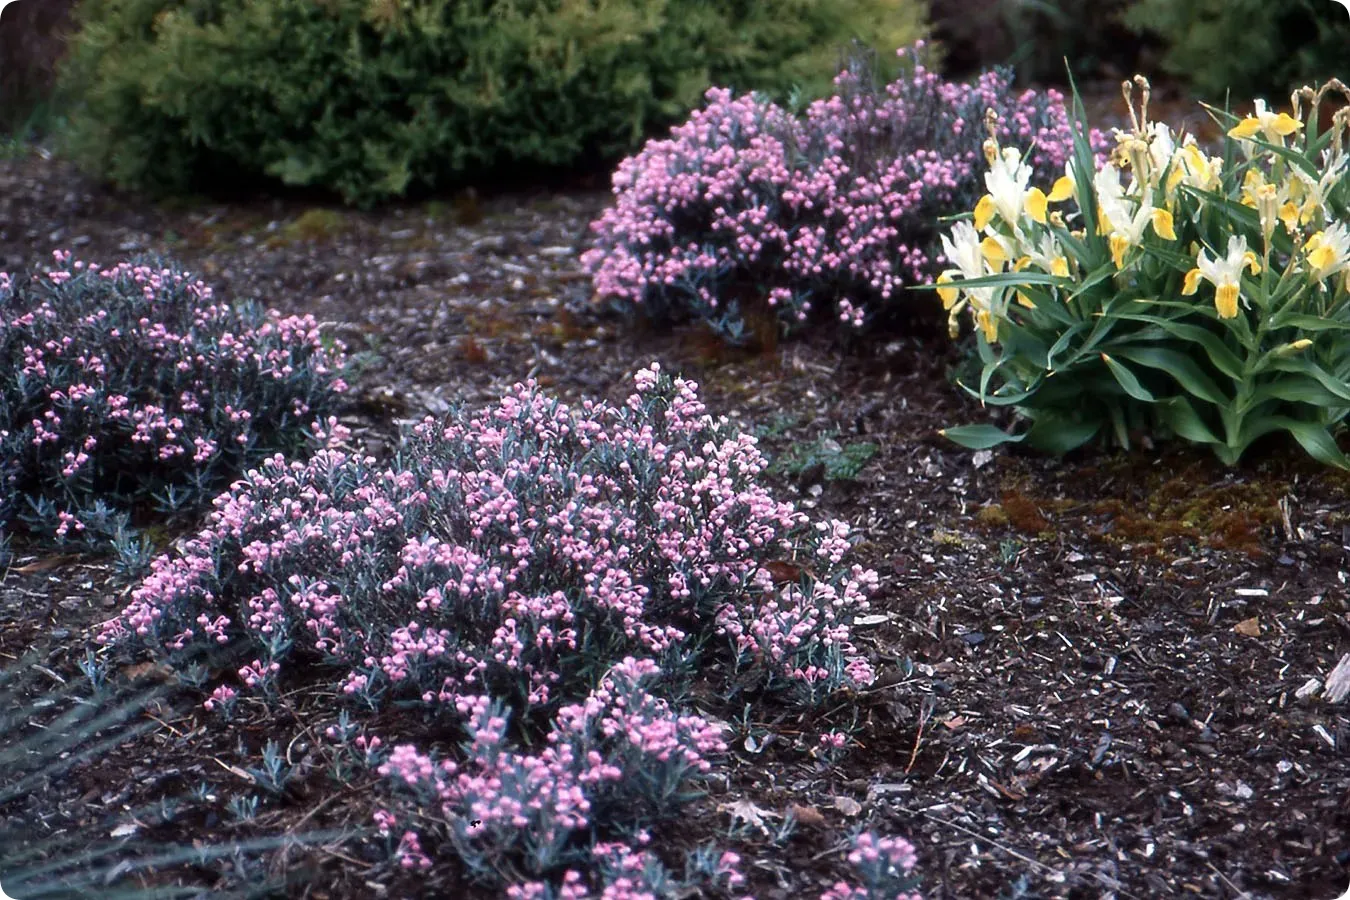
[63,0,923,204]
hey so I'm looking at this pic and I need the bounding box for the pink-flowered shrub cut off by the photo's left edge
[0,251,346,544]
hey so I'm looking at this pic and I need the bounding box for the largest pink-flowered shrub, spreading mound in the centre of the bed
[103,364,878,714]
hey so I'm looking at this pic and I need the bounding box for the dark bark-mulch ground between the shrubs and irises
[0,147,1350,900]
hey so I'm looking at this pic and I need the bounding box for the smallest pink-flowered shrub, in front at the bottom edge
[379,657,737,897]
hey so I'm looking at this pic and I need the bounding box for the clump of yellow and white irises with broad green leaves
[936,77,1350,467]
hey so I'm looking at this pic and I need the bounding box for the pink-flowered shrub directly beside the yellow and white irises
[582,42,1104,343]
